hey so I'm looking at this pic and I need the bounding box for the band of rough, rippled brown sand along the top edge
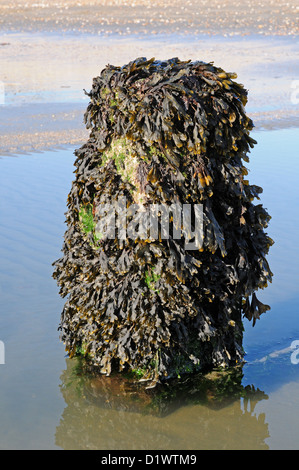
[0,0,298,35]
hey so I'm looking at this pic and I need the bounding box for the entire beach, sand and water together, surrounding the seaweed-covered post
[0,0,299,452]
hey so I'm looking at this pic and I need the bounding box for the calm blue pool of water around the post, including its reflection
[0,129,299,450]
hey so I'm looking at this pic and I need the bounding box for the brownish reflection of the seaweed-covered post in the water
[55,358,269,450]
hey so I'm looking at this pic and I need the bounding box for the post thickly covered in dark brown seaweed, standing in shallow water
[54,58,272,385]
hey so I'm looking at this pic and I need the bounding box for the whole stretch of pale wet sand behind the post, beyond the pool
[0,0,299,155]
